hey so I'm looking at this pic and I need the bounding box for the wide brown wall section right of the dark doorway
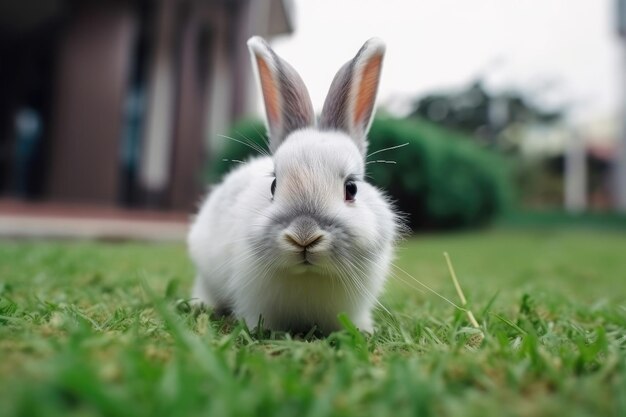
[48,5,135,205]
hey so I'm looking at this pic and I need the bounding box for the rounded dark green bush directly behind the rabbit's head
[210,118,510,230]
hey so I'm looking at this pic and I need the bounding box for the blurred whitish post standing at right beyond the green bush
[565,130,587,213]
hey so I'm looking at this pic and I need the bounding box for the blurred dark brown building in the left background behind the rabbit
[0,0,292,211]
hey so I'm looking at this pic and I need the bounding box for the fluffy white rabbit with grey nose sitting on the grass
[188,37,400,333]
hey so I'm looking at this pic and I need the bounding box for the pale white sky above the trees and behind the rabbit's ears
[272,0,625,122]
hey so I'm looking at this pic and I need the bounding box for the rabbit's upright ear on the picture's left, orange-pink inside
[248,36,315,152]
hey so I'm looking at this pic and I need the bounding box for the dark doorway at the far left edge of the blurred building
[0,13,61,199]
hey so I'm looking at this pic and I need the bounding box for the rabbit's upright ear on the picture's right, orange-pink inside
[319,38,385,155]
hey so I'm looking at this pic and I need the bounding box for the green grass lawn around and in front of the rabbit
[0,229,626,417]
